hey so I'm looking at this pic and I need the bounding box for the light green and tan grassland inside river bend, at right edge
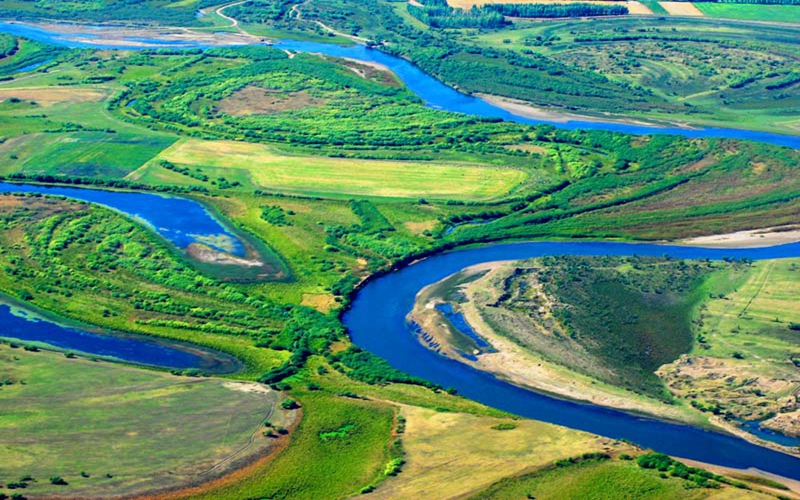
[660,259,800,436]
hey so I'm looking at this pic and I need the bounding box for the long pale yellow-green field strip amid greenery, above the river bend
[141,139,527,200]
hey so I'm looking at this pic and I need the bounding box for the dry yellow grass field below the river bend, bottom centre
[373,406,631,499]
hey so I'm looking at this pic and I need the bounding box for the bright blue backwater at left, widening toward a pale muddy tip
[0,182,246,256]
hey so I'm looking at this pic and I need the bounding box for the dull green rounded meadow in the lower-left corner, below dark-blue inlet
[0,344,294,498]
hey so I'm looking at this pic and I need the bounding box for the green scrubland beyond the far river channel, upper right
[240,0,800,135]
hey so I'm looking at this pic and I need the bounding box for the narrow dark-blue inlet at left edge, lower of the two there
[0,303,228,369]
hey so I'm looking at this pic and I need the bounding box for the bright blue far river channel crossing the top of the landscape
[0,22,800,149]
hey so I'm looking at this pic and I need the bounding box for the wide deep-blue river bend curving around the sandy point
[343,242,800,479]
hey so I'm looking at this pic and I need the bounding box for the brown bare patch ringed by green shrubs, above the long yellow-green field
[217,85,327,116]
